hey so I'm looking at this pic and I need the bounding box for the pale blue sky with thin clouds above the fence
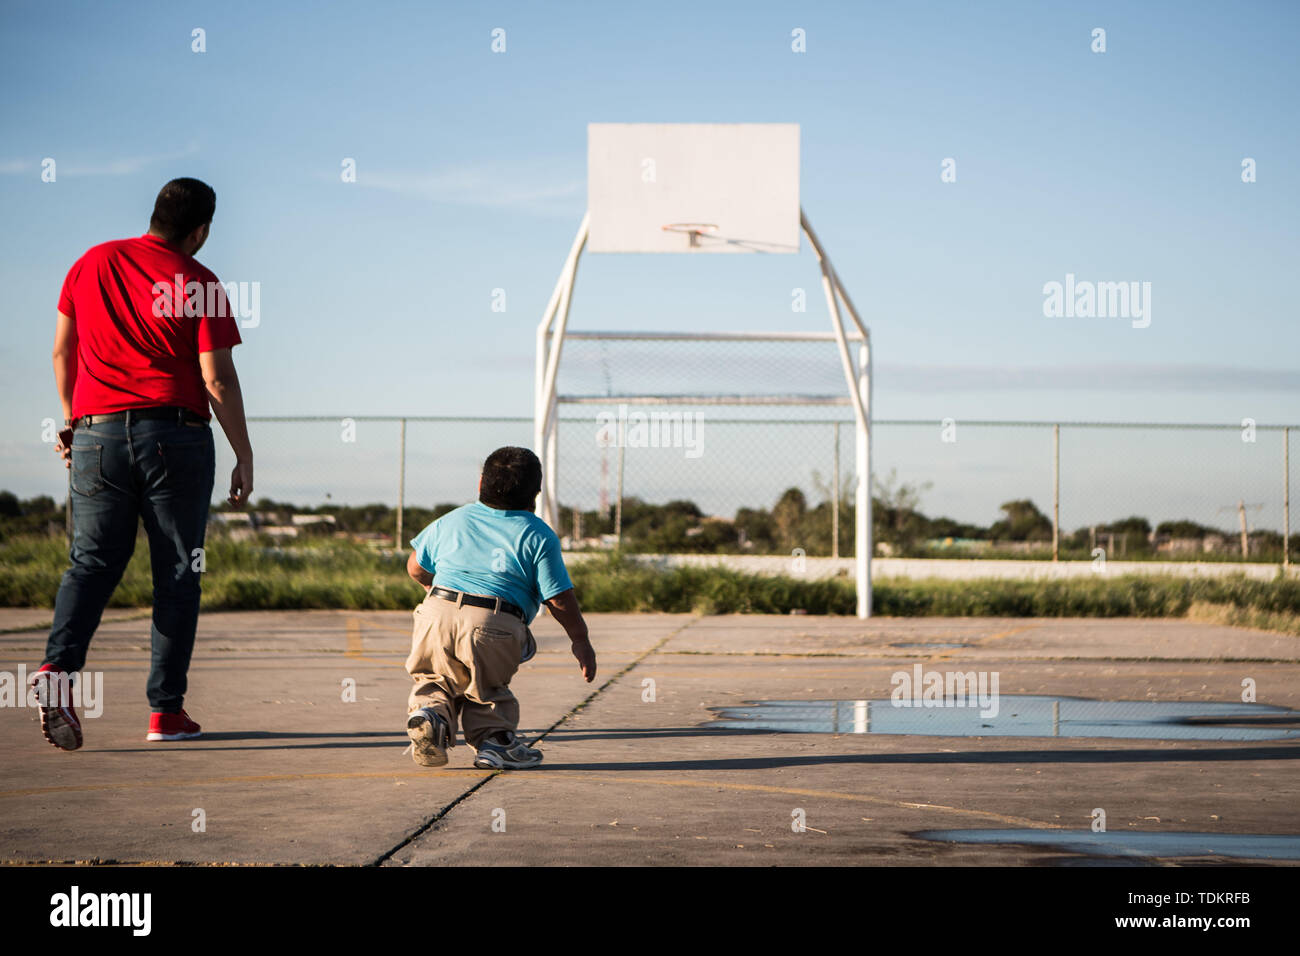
[0,3,1300,519]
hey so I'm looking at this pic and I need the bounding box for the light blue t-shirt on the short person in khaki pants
[411,501,573,623]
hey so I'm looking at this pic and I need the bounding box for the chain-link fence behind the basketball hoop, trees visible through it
[218,416,1296,562]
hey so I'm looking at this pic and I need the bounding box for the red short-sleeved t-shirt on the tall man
[59,235,241,419]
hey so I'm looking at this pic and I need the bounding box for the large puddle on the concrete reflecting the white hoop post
[703,695,1300,741]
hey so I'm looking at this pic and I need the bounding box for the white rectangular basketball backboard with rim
[586,122,800,252]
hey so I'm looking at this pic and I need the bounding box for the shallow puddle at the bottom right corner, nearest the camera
[913,830,1300,860]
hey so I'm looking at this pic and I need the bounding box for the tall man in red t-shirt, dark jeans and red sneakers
[33,178,252,750]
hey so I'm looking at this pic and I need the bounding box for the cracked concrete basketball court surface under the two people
[0,610,1300,865]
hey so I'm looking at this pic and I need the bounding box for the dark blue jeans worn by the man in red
[46,420,216,713]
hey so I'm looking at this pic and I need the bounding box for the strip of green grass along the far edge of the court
[0,537,1300,624]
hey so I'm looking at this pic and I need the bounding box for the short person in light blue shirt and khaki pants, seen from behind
[407,447,595,770]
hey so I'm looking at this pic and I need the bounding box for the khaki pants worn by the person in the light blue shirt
[407,594,528,749]
